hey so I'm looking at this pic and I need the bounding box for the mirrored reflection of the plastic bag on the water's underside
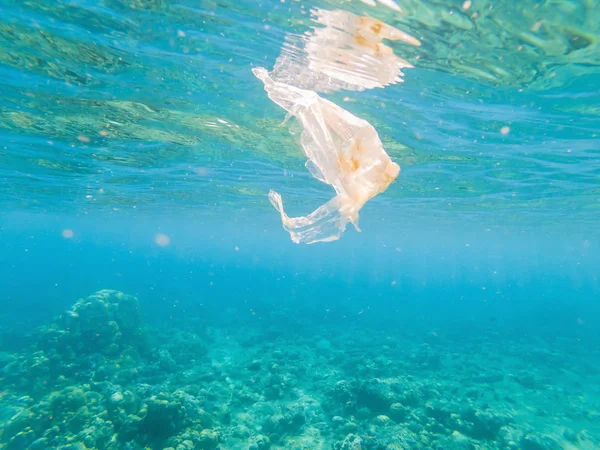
[271,9,421,92]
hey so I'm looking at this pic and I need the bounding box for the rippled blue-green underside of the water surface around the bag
[0,0,600,225]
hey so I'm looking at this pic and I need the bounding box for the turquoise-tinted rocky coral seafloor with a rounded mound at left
[0,290,600,450]
